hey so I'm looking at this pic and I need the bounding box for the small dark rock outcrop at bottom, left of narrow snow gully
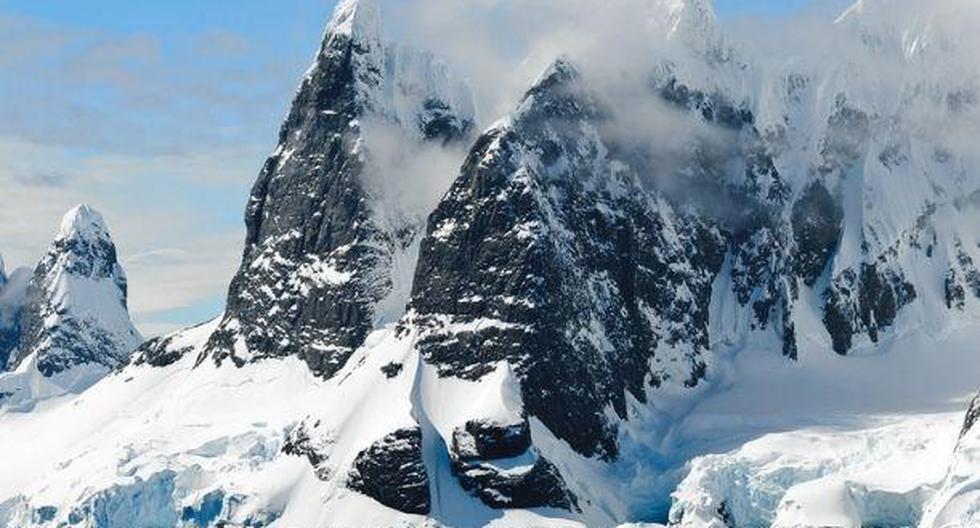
[347,428,432,515]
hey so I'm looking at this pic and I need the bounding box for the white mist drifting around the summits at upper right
[372,0,980,229]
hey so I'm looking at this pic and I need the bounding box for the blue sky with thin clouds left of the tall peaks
[0,0,836,334]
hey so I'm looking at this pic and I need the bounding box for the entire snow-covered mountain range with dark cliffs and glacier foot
[0,0,980,528]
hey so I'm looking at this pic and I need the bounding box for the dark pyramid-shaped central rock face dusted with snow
[409,61,723,457]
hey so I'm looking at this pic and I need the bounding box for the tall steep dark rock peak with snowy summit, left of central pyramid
[202,0,473,378]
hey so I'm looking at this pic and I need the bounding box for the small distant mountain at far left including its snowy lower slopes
[0,205,142,408]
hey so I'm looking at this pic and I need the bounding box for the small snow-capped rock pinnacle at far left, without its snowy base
[13,205,142,377]
